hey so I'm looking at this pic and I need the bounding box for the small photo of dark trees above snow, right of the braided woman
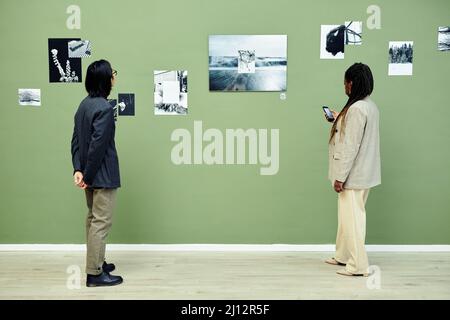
[388,41,414,76]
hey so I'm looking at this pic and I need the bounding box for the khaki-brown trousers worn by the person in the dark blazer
[85,189,117,275]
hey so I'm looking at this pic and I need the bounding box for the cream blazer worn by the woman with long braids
[328,97,381,189]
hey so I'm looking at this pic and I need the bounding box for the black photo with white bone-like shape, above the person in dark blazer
[48,38,82,82]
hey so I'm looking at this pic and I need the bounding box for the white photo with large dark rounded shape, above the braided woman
[320,24,345,59]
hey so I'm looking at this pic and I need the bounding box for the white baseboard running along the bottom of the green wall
[0,244,450,252]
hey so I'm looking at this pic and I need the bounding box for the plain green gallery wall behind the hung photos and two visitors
[0,0,450,244]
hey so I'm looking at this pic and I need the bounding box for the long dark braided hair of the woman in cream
[329,62,373,142]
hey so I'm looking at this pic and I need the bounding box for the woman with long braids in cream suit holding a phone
[326,63,381,276]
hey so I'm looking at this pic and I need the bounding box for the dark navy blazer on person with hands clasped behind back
[72,96,120,188]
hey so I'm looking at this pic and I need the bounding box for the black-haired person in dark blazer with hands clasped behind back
[71,60,123,287]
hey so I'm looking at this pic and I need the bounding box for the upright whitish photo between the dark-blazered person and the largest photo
[153,70,188,115]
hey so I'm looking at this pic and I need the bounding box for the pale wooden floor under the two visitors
[0,251,450,300]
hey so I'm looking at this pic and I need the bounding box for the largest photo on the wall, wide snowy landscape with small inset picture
[209,35,287,91]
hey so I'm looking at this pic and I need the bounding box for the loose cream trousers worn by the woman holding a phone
[335,189,370,274]
